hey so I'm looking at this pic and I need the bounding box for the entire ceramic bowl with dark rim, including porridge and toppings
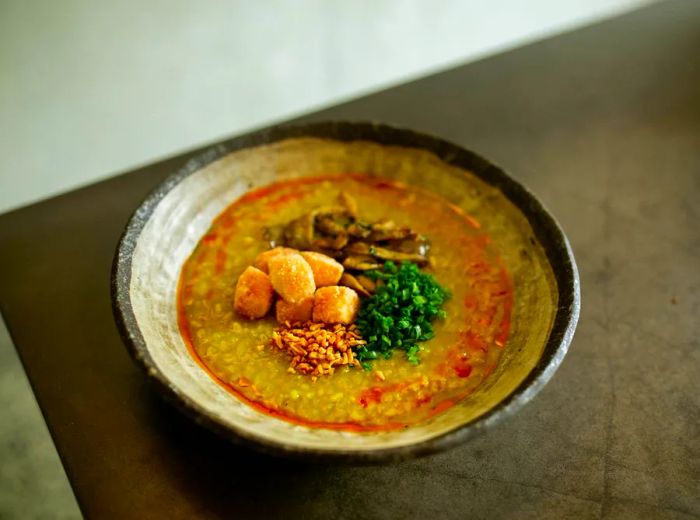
[112,122,580,461]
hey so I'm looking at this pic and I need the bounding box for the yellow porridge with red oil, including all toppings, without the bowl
[178,174,513,432]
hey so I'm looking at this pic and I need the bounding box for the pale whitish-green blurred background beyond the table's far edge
[0,0,648,212]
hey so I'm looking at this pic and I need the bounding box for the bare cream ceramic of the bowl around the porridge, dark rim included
[112,122,580,461]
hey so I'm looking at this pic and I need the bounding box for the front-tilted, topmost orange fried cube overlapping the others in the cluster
[268,252,316,303]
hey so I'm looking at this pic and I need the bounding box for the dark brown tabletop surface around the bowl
[0,0,700,519]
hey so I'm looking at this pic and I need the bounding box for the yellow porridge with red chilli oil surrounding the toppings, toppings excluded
[178,175,513,431]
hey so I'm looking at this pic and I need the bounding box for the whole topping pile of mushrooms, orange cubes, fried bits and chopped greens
[234,193,449,378]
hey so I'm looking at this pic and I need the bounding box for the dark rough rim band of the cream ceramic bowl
[111,121,581,462]
